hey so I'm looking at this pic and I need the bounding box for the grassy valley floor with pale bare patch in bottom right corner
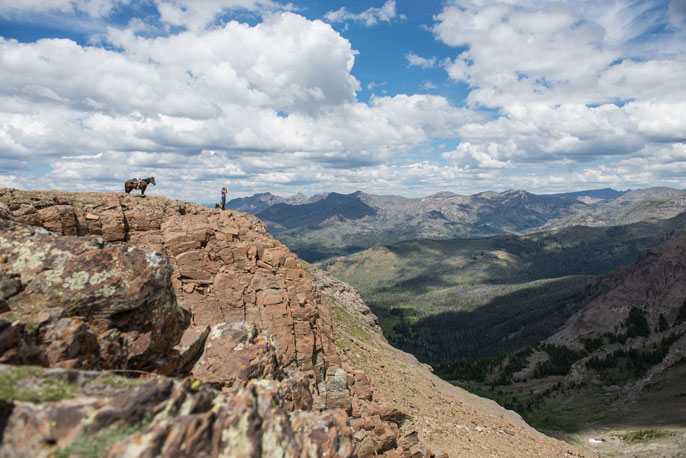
[460,362,686,458]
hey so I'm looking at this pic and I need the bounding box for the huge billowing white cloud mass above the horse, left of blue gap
[0,12,479,198]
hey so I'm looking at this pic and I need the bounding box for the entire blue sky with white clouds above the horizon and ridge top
[0,0,686,202]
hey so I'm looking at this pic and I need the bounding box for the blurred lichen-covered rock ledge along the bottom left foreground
[0,365,354,458]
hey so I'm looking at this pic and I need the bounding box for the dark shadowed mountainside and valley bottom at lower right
[452,236,686,457]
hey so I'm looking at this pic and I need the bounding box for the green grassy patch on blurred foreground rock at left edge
[0,366,79,403]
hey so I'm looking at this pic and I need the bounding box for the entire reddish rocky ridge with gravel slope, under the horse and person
[0,189,586,457]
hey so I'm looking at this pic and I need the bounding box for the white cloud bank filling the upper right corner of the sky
[433,0,686,182]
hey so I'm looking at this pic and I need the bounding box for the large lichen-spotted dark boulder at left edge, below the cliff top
[0,219,188,369]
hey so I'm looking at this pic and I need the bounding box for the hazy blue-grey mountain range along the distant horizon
[229,187,686,262]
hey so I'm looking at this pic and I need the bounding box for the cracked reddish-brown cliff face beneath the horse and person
[0,189,340,379]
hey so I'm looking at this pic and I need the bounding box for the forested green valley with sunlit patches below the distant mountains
[322,216,686,368]
